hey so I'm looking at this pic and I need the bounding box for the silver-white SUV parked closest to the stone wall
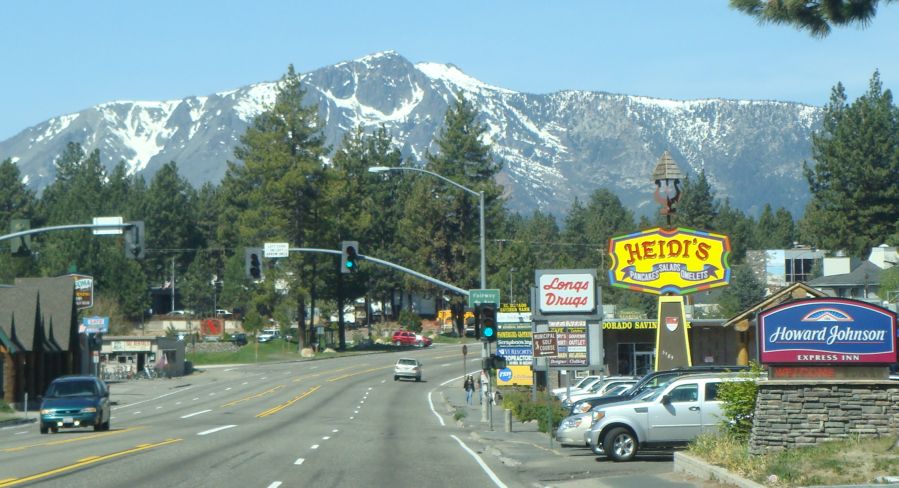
[584,373,751,461]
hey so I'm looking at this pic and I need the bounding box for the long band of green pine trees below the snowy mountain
[0,66,899,346]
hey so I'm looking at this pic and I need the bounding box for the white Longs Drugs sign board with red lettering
[537,273,596,314]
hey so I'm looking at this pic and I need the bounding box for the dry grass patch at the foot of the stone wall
[688,434,899,487]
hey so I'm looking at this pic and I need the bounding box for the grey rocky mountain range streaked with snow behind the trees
[0,52,822,216]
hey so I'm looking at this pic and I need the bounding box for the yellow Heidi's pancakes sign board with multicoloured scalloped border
[609,227,730,295]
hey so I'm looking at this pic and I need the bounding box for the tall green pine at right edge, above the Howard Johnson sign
[799,72,899,257]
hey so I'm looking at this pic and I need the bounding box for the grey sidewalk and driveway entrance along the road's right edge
[441,379,725,488]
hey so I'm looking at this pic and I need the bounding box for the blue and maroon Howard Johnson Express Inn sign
[759,298,896,364]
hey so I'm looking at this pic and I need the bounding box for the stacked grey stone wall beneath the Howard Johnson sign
[749,380,899,454]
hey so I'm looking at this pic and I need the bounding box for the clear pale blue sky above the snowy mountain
[0,0,899,140]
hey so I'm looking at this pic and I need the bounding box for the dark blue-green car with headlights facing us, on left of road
[40,376,111,434]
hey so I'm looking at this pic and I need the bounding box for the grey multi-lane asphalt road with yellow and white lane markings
[0,346,728,488]
